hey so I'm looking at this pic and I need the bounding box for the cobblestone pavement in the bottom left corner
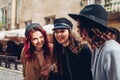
[0,62,23,80]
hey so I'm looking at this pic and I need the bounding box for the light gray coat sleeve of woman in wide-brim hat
[104,49,120,80]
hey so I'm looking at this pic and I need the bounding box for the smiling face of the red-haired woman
[31,31,45,51]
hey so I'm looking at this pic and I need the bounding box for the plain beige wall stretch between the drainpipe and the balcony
[20,0,80,31]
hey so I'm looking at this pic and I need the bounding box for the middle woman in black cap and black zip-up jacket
[53,18,92,80]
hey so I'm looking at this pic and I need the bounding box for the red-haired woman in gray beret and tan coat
[21,23,53,80]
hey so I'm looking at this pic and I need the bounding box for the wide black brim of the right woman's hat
[68,14,114,32]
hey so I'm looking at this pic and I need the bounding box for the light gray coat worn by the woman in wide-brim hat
[92,40,120,80]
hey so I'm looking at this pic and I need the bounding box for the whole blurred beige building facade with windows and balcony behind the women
[0,0,120,31]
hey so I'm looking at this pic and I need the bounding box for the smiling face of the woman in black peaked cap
[54,29,69,45]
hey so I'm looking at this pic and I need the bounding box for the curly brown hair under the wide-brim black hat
[78,22,115,49]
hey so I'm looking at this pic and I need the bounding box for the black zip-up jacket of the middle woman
[63,45,92,80]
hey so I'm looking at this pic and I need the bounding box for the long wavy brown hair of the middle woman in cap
[53,29,82,74]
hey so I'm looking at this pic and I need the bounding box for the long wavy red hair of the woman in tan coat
[24,27,50,61]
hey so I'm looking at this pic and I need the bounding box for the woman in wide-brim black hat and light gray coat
[69,4,120,80]
